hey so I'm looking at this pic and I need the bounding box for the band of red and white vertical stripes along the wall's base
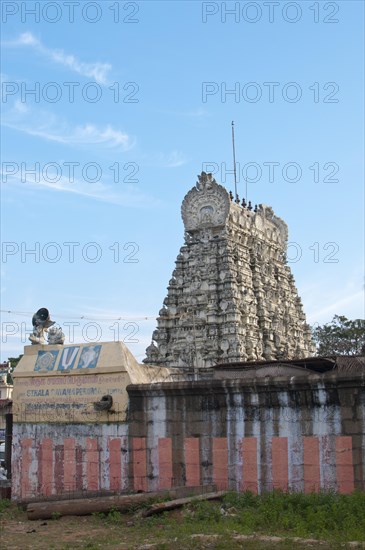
[13,434,355,500]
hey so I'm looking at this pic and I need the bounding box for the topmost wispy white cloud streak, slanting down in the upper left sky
[4,32,112,86]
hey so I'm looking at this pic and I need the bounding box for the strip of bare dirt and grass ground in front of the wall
[0,491,365,550]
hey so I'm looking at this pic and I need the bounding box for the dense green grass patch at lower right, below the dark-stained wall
[179,491,365,542]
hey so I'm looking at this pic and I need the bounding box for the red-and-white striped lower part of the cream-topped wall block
[12,423,129,500]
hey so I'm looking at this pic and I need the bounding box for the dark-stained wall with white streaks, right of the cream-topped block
[128,374,365,493]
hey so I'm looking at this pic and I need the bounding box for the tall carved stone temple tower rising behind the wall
[144,172,315,368]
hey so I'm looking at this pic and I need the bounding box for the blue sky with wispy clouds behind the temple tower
[1,0,364,360]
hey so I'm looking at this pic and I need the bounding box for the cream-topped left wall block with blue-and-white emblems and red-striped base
[12,342,171,500]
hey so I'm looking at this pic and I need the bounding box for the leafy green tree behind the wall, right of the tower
[312,315,365,356]
